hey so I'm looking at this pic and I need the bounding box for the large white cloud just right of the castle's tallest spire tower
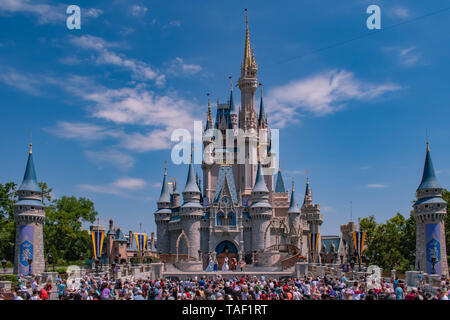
[266,70,400,127]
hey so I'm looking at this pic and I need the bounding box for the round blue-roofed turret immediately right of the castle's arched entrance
[250,162,272,251]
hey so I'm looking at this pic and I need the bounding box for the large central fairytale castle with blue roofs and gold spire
[155,12,326,266]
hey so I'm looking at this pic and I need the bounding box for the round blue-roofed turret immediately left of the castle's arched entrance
[179,158,203,258]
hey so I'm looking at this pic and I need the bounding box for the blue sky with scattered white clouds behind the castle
[0,0,450,234]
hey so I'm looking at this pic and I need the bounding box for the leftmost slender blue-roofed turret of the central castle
[153,162,172,253]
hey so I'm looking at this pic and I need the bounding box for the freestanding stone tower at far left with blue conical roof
[14,144,45,274]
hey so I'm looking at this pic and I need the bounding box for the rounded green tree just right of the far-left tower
[44,196,98,261]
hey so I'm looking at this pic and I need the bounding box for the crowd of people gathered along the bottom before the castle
[4,274,450,300]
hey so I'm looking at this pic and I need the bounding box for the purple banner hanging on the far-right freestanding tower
[425,223,441,274]
